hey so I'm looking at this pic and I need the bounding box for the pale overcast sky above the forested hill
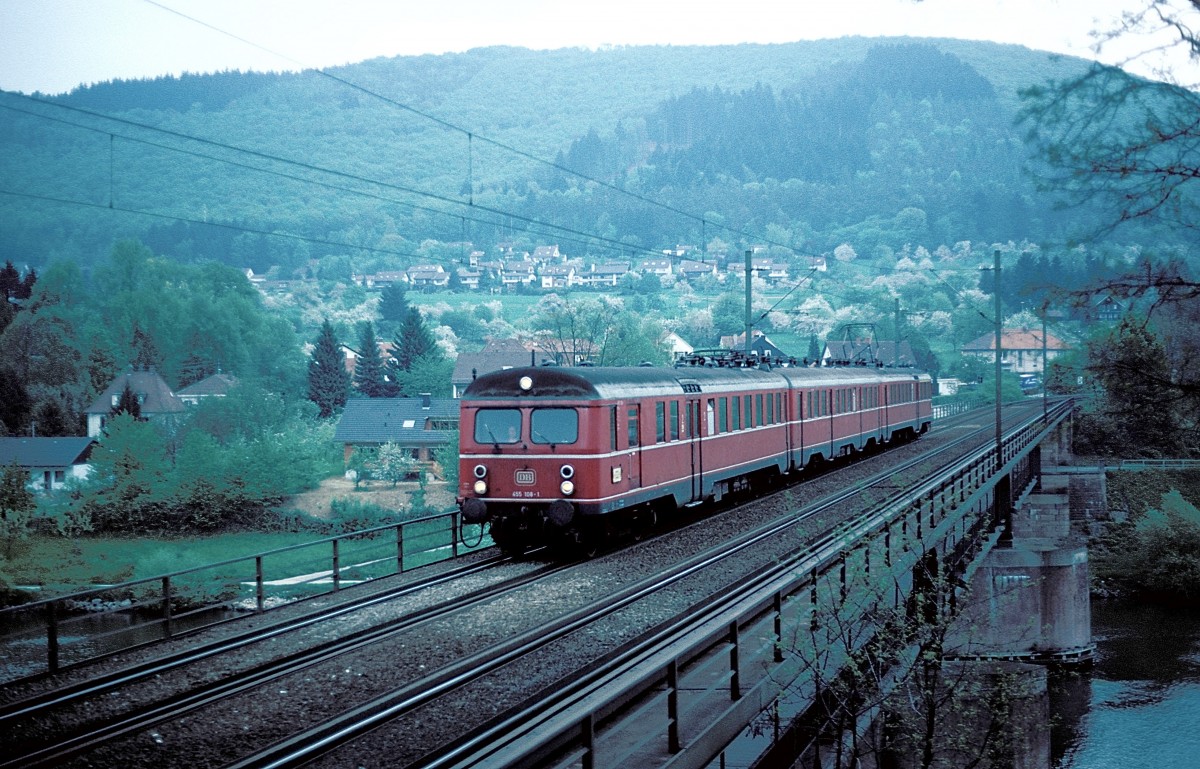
[0,0,1171,94]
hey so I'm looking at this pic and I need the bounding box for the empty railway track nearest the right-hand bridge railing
[290,405,1051,769]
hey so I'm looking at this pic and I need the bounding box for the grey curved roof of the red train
[462,366,928,399]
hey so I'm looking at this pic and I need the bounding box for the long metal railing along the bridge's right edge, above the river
[470,395,1070,768]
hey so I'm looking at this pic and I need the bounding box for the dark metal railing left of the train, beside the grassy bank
[0,510,491,681]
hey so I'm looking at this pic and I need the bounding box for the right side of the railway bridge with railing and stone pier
[460,401,1093,769]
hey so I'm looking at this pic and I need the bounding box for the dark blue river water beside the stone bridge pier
[1050,601,1200,769]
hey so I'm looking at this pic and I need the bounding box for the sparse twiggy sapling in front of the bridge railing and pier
[777,547,1039,769]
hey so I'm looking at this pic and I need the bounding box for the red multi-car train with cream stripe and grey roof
[458,366,932,551]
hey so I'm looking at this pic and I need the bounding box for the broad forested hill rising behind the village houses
[0,38,1161,277]
